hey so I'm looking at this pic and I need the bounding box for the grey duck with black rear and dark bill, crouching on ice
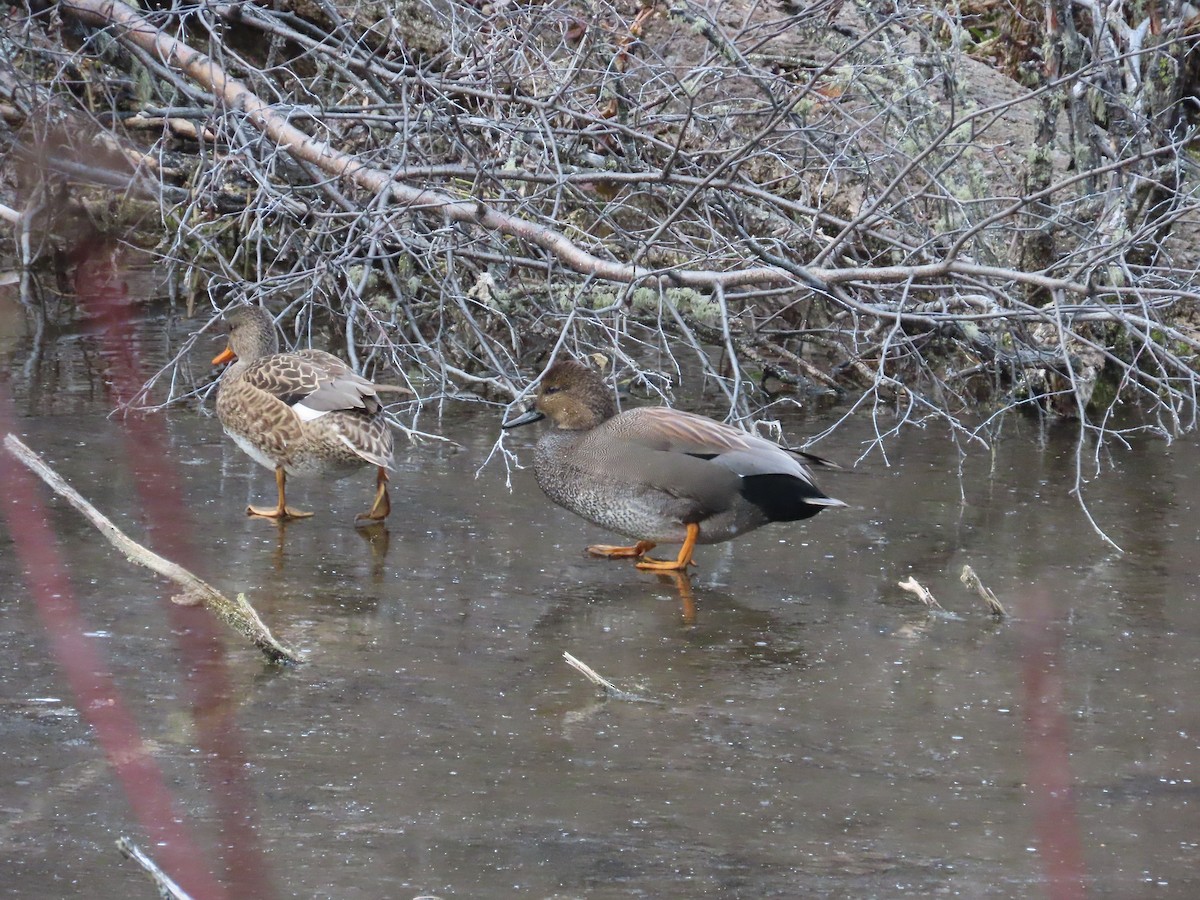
[503,360,846,571]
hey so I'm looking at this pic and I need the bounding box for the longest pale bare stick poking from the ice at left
[4,434,302,662]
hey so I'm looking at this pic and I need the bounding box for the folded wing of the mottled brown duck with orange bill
[241,350,379,421]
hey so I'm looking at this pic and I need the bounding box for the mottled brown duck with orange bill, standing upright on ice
[212,306,400,521]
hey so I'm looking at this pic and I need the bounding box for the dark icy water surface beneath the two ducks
[0,293,1200,900]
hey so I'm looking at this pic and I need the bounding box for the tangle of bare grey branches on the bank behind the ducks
[0,0,1200,540]
